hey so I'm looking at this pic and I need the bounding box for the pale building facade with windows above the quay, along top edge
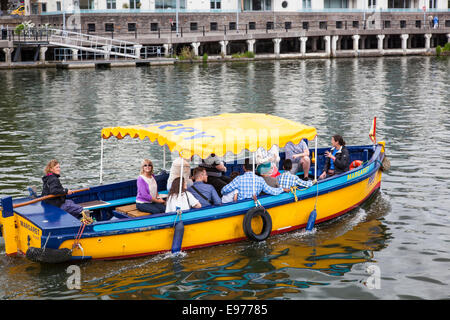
[20,0,450,15]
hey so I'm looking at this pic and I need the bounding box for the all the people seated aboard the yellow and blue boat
[42,135,349,217]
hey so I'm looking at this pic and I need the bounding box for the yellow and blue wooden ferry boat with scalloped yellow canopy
[0,113,386,263]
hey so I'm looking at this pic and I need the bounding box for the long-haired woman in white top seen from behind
[166,177,202,212]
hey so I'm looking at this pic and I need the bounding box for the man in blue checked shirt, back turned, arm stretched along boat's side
[222,159,290,201]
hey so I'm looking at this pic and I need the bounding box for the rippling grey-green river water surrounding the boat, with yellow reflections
[0,57,450,300]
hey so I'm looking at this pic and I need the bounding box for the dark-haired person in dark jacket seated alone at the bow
[319,134,350,179]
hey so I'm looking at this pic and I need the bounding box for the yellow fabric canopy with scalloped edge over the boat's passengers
[102,113,316,159]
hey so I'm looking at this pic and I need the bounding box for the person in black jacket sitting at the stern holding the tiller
[41,159,90,219]
